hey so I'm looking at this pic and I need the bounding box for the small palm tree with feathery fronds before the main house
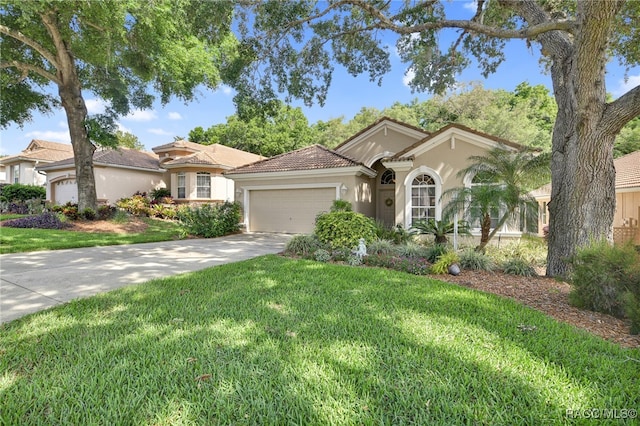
[442,147,551,251]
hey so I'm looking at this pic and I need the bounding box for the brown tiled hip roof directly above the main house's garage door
[227,145,364,174]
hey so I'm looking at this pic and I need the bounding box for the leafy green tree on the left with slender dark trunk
[0,0,236,209]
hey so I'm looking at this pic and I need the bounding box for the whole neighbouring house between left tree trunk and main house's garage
[37,140,264,204]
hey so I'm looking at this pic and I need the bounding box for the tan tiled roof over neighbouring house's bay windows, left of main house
[153,140,264,169]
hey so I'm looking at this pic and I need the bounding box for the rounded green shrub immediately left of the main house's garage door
[177,201,240,238]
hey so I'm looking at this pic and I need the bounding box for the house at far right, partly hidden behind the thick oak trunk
[533,151,640,244]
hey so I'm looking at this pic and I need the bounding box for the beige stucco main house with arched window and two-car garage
[225,117,520,236]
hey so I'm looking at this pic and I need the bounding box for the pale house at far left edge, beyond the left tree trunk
[0,139,73,186]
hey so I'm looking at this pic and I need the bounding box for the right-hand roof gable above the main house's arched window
[393,123,524,160]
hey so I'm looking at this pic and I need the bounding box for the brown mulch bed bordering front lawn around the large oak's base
[433,270,640,348]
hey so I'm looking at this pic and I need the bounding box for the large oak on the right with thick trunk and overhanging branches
[227,0,640,275]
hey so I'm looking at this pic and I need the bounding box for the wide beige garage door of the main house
[249,188,336,234]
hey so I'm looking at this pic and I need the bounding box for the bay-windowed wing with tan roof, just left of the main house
[152,140,264,203]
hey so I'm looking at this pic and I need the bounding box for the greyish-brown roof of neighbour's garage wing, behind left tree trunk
[37,148,164,172]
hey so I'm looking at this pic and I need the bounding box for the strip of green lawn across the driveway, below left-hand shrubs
[0,219,185,253]
